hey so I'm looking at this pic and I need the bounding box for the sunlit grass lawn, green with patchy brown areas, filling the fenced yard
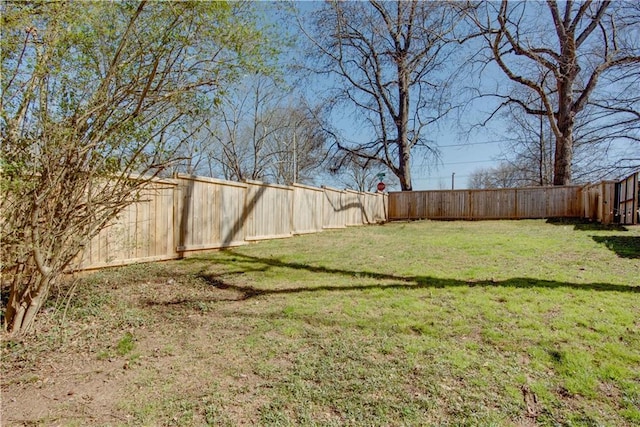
[5,220,640,426]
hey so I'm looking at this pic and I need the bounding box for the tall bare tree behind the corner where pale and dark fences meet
[300,0,459,190]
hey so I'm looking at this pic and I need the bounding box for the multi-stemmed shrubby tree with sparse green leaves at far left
[0,1,266,333]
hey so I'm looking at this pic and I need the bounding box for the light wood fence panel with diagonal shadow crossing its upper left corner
[244,181,293,240]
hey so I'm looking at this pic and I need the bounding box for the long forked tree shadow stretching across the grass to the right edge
[142,251,640,305]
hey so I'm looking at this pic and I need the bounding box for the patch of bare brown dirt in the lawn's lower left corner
[0,272,269,426]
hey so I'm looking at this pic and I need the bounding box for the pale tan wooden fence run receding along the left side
[80,175,388,269]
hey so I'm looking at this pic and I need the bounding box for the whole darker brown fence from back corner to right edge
[389,177,640,225]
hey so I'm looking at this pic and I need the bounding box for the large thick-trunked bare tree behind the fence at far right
[470,0,640,185]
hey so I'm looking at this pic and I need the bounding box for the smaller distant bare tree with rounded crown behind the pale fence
[200,75,326,184]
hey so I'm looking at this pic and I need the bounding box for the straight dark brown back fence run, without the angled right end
[389,186,582,221]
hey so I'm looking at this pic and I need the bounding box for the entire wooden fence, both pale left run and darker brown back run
[80,173,640,269]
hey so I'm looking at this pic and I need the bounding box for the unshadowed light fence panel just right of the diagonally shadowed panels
[293,184,324,234]
